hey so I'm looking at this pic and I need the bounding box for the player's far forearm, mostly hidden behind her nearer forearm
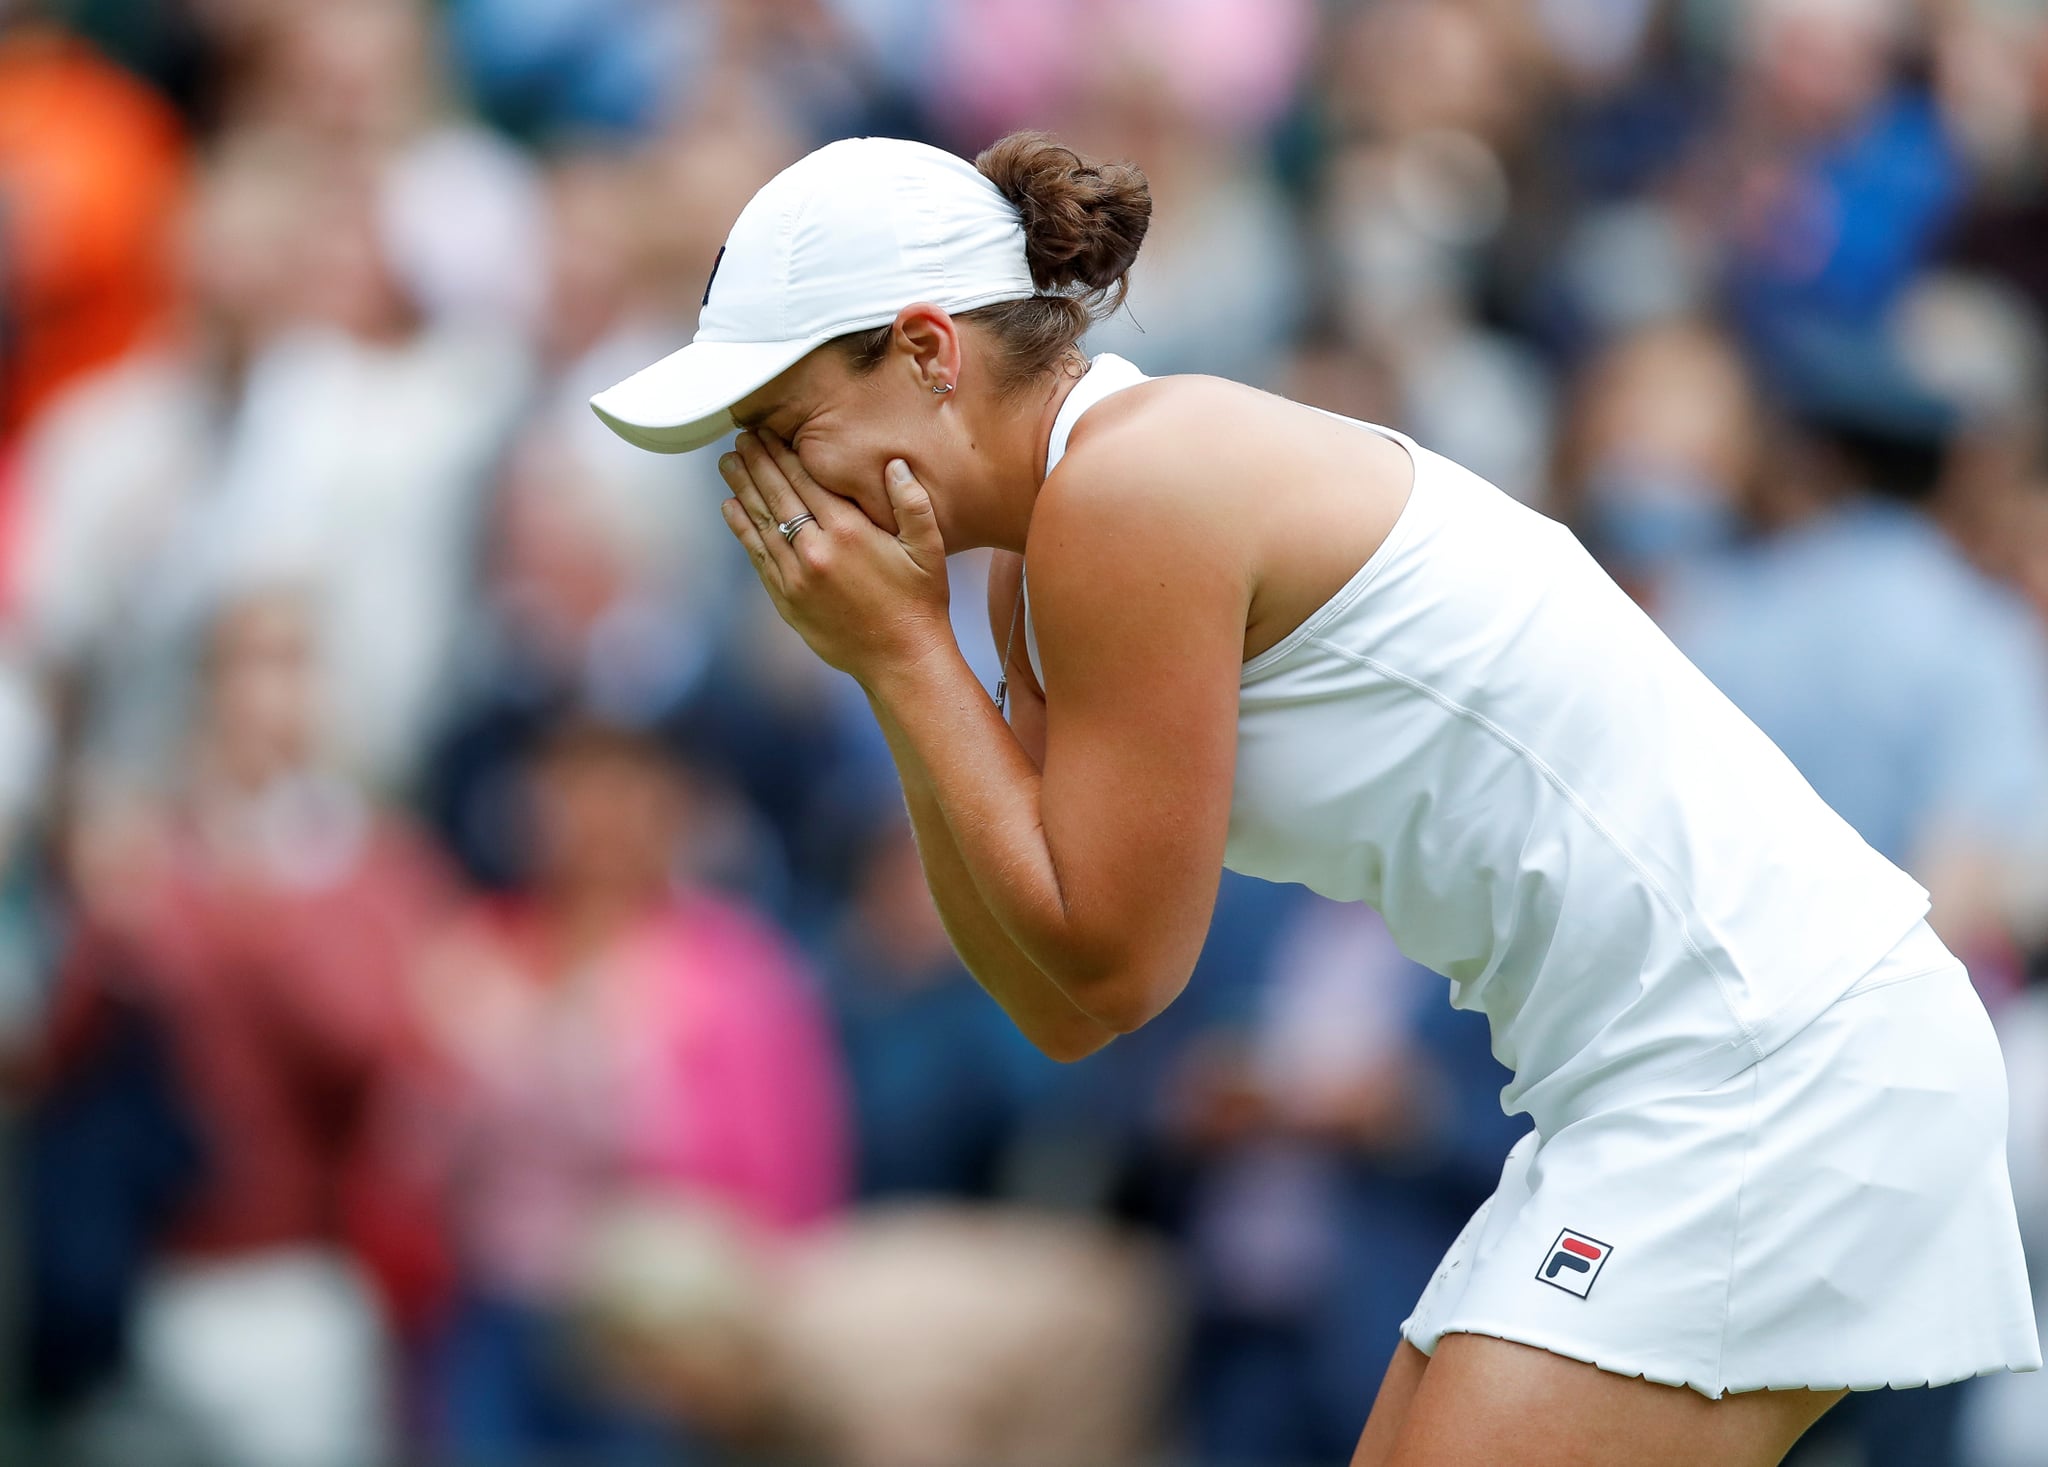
[868,695,1116,1059]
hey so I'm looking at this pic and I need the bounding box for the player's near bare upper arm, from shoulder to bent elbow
[1030,432,1249,1022]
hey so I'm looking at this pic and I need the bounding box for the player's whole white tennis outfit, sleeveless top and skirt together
[1024,357,2042,1395]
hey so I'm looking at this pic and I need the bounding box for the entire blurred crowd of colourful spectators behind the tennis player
[0,0,2048,1467]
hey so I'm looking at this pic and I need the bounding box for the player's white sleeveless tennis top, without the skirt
[1024,354,1927,1135]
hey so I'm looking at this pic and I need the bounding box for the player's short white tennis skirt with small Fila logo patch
[1403,924,2042,1397]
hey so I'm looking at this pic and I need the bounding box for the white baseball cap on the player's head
[590,137,1038,453]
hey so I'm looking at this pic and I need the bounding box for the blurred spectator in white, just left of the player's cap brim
[150,153,524,789]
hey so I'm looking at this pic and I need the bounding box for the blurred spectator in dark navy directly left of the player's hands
[422,426,887,912]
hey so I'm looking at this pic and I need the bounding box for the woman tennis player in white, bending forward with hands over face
[592,133,2040,1467]
